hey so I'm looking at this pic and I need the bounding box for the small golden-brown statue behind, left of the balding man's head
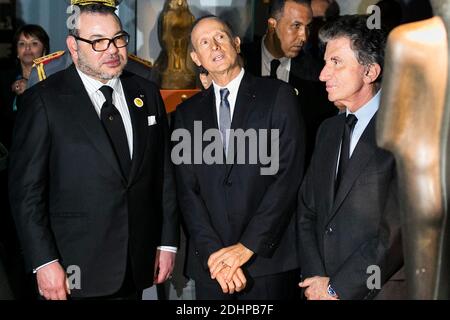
[161,0,196,89]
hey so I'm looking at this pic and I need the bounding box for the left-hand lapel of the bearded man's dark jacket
[60,65,123,182]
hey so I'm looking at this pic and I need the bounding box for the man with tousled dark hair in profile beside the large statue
[299,16,403,299]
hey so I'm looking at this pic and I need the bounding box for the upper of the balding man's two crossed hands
[208,243,253,282]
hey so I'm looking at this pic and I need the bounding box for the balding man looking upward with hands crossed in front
[174,17,304,299]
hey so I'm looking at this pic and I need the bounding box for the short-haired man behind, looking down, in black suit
[242,0,338,163]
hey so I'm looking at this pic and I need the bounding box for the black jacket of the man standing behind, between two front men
[242,39,338,169]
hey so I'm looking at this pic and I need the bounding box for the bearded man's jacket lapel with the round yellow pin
[120,74,148,183]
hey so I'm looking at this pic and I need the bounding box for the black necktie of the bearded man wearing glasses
[100,86,131,177]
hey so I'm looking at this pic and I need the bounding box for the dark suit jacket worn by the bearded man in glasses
[9,65,178,297]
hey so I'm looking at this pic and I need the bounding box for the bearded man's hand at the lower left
[36,261,70,300]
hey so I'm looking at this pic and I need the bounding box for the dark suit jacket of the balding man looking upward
[175,73,304,281]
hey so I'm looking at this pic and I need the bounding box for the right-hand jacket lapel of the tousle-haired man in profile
[328,114,377,221]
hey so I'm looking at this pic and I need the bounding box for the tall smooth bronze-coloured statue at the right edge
[377,0,450,299]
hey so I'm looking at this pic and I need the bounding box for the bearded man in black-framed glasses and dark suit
[10,4,178,299]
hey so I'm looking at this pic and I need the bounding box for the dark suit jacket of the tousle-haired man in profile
[299,114,403,299]
